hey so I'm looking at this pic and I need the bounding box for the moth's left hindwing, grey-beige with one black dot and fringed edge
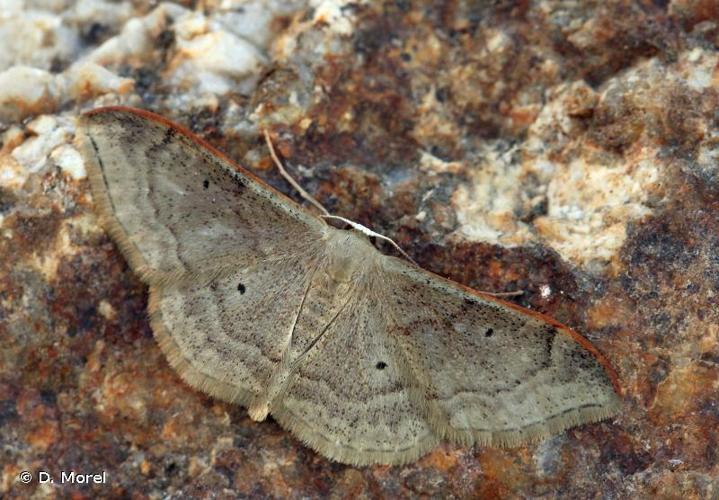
[149,254,316,406]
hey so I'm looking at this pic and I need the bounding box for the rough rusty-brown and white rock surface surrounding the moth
[0,0,719,499]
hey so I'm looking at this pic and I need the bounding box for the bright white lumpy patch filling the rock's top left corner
[0,0,306,122]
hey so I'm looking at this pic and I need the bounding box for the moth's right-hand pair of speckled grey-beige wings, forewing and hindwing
[272,257,619,465]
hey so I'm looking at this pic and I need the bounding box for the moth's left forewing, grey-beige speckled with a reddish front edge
[80,108,322,283]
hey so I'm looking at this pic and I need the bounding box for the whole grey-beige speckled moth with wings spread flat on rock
[79,107,620,465]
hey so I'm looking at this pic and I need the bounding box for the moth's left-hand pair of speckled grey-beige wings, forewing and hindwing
[80,104,324,405]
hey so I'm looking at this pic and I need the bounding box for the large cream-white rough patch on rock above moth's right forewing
[452,49,719,272]
